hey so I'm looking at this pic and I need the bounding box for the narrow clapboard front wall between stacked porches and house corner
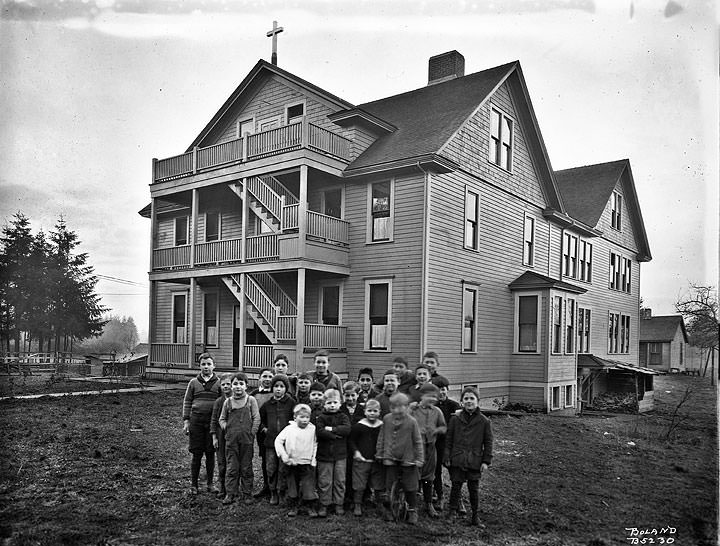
[343,173,424,376]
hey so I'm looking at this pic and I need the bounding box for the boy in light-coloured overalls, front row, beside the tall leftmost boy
[218,372,260,504]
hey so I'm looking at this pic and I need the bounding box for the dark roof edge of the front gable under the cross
[186,59,354,152]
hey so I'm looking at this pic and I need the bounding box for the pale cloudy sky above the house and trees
[0,0,719,339]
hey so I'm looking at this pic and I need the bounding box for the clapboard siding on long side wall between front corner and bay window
[427,169,548,383]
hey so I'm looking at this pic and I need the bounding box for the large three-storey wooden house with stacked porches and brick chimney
[141,51,652,411]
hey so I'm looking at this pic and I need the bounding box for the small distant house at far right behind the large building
[640,309,692,372]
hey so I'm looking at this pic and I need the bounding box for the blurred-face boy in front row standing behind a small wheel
[375,393,425,525]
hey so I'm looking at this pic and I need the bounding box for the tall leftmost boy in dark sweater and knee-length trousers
[183,353,221,495]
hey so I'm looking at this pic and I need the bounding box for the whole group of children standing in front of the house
[183,350,493,525]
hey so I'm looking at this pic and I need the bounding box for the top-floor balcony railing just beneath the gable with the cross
[153,120,351,182]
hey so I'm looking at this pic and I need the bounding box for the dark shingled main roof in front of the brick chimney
[345,61,569,211]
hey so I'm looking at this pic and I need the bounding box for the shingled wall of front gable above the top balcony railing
[214,75,341,145]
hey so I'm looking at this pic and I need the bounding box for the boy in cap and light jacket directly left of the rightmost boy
[410,374,447,518]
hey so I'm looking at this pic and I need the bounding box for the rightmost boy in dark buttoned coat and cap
[445,387,493,525]
